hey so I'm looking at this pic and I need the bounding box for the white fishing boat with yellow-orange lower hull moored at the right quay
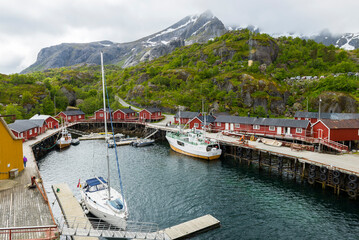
[166,109,222,160]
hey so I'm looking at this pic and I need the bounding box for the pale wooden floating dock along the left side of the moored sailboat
[51,183,98,240]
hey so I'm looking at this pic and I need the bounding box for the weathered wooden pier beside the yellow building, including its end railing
[0,131,58,239]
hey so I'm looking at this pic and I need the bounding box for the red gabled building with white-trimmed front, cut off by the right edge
[313,119,359,142]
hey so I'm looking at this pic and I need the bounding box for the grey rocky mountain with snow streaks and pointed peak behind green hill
[21,11,227,73]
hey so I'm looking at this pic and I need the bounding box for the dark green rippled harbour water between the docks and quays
[39,141,359,239]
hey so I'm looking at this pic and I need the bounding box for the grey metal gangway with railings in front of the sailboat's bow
[58,216,170,240]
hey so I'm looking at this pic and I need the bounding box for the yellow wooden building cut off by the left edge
[0,117,24,179]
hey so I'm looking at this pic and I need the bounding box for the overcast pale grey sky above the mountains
[0,0,359,74]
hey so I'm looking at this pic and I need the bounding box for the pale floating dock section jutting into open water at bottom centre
[162,214,220,240]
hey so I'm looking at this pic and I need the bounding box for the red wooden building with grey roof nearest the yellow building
[8,120,40,141]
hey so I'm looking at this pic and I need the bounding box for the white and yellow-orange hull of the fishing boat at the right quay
[166,134,222,160]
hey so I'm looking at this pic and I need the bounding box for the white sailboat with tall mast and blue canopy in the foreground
[81,52,128,230]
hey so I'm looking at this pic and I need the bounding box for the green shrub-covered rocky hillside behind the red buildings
[0,30,359,123]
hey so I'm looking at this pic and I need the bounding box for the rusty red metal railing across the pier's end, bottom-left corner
[0,225,59,240]
